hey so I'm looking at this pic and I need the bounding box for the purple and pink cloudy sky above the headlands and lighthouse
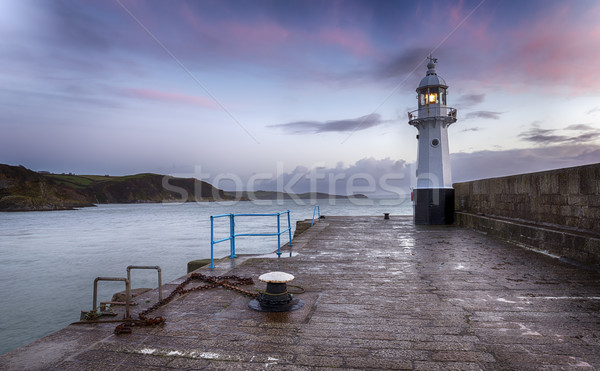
[0,0,600,194]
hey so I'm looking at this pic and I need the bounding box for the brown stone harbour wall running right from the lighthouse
[454,163,600,266]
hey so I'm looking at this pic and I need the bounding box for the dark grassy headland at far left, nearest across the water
[0,164,232,211]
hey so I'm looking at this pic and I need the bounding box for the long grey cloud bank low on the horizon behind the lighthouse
[254,144,600,197]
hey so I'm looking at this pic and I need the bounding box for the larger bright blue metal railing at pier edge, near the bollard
[210,210,292,268]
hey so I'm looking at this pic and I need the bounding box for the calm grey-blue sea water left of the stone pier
[0,200,412,354]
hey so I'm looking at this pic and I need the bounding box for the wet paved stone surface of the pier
[0,216,600,370]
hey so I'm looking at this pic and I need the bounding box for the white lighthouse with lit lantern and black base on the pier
[408,56,456,224]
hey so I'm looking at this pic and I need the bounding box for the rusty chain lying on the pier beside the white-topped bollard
[114,273,258,335]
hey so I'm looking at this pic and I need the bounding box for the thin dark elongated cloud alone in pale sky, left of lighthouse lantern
[269,113,388,134]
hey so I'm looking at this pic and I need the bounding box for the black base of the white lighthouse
[413,188,454,224]
